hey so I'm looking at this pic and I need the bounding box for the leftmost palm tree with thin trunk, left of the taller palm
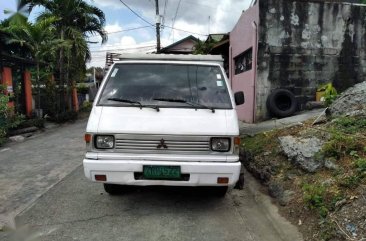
[3,17,62,115]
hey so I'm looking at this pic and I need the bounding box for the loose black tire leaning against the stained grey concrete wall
[267,89,297,117]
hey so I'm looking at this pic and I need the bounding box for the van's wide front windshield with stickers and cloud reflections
[98,63,232,109]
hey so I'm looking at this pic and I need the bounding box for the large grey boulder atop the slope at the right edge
[327,81,366,117]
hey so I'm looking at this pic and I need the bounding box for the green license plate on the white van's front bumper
[143,166,181,179]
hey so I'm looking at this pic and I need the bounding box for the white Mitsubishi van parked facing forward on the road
[83,54,244,195]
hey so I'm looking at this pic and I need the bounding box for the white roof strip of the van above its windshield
[111,54,224,64]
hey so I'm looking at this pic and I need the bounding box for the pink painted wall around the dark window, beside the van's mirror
[229,1,259,123]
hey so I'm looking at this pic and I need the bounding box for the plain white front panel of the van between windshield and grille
[87,106,239,136]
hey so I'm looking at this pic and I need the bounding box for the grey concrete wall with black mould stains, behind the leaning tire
[256,0,366,120]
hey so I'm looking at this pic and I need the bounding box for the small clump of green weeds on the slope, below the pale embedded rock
[302,184,329,217]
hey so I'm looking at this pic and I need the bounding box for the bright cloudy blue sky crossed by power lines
[0,0,251,67]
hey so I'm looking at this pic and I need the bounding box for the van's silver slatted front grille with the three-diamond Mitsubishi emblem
[115,135,210,153]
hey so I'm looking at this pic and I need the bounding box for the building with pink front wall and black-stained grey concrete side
[229,0,366,123]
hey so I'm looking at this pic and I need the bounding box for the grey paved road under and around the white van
[0,119,299,241]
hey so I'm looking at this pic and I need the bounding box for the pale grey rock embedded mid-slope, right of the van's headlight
[279,136,323,172]
